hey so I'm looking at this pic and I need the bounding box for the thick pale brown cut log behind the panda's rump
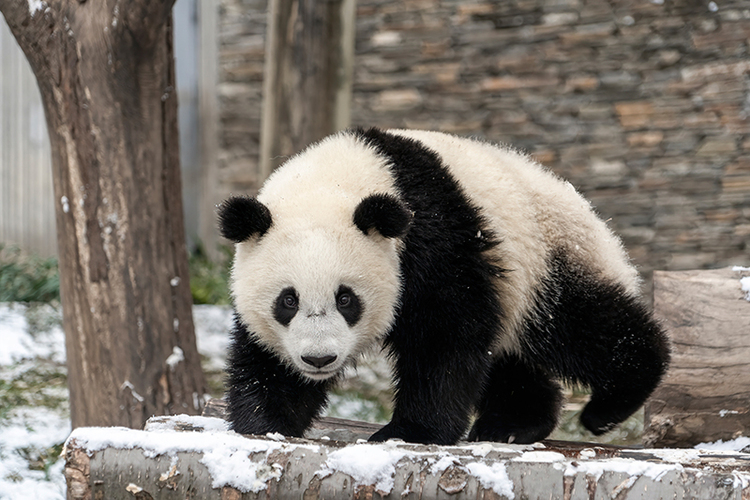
[643,267,750,447]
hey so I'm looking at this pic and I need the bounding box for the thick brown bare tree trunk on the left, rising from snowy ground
[0,0,206,427]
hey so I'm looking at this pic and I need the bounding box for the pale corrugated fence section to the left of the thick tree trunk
[0,20,57,256]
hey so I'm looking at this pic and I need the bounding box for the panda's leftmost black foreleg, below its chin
[227,320,331,437]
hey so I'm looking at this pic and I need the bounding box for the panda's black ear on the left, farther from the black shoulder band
[219,196,271,243]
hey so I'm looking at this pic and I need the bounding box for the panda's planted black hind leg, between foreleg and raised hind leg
[469,355,562,443]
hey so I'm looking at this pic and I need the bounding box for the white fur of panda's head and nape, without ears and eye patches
[232,135,400,379]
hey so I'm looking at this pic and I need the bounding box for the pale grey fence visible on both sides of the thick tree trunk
[0,0,217,256]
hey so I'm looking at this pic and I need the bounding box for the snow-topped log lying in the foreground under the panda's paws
[65,415,750,500]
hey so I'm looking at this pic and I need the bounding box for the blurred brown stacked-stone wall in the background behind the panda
[221,0,750,292]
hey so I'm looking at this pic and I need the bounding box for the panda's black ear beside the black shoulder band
[354,194,413,238]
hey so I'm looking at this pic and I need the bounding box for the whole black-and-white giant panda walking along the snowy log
[218,128,669,444]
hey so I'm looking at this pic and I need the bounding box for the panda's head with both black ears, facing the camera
[219,193,412,380]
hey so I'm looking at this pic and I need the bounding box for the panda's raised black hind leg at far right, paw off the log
[523,251,669,435]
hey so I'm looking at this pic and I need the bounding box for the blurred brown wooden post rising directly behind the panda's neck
[258,0,355,181]
